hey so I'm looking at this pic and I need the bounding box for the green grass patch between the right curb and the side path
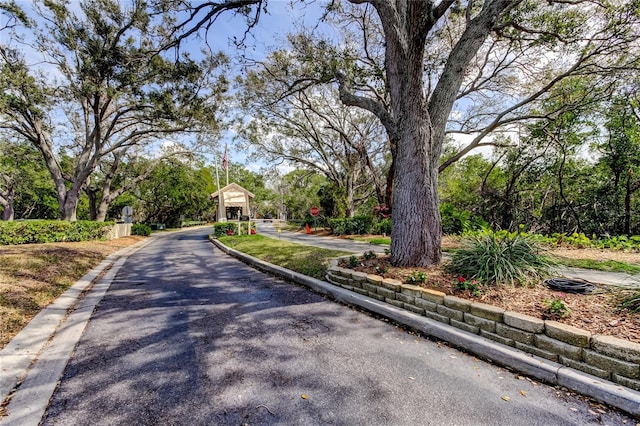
[219,235,350,280]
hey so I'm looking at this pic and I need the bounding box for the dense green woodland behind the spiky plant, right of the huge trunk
[441,87,640,236]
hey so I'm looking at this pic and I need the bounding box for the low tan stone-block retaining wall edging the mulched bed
[326,261,640,391]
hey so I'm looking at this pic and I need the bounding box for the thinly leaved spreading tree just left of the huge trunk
[240,63,389,217]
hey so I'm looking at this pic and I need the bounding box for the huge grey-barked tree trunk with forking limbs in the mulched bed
[336,0,520,266]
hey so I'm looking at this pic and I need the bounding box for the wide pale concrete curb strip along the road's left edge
[0,238,153,426]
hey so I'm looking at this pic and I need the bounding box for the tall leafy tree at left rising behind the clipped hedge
[0,0,226,220]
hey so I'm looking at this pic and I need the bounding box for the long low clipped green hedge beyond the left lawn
[0,220,114,245]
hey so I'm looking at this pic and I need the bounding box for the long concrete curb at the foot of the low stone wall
[211,239,640,416]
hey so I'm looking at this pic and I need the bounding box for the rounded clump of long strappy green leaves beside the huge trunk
[449,233,554,284]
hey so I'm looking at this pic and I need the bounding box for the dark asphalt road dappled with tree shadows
[42,229,635,425]
